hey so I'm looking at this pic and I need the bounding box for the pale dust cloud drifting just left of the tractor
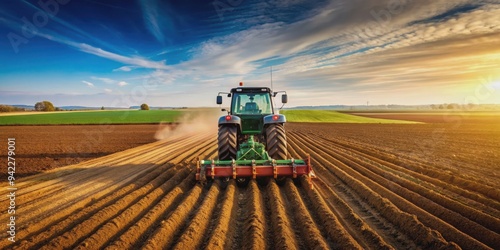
[155,108,225,140]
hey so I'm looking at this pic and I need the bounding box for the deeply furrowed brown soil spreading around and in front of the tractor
[0,128,500,249]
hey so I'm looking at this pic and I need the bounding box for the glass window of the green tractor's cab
[232,93,272,114]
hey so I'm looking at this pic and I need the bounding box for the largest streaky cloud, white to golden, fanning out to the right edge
[175,0,500,97]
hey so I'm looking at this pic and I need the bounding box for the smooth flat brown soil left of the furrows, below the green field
[0,125,164,179]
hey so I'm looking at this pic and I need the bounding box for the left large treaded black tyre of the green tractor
[218,126,238,161]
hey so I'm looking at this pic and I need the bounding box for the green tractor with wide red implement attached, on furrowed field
[196,83,312,186]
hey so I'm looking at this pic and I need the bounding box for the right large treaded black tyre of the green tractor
[266,124,288,160]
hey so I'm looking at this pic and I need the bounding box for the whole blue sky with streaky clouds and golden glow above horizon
[0,0,500,107]
